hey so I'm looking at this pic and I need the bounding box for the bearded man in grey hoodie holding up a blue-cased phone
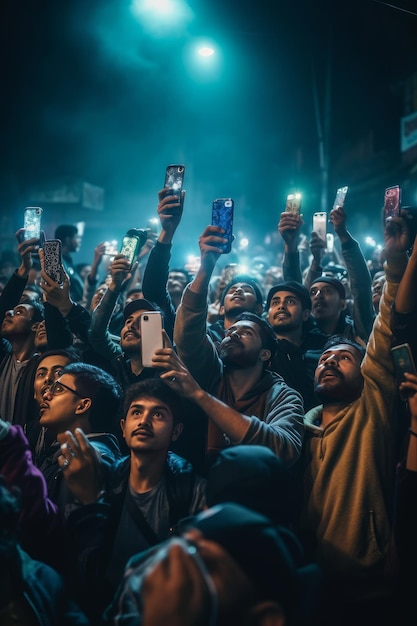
[172,225,303,465]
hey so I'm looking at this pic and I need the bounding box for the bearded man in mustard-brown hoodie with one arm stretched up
[292,213,409,625]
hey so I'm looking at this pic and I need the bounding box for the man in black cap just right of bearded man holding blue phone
[266,280,328,411]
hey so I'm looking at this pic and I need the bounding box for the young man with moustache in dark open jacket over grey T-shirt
[59,378,206,623]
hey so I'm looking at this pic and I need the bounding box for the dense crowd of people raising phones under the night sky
[0,189,417,626]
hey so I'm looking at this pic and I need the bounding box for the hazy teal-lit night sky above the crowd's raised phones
[0,0,417,260]
